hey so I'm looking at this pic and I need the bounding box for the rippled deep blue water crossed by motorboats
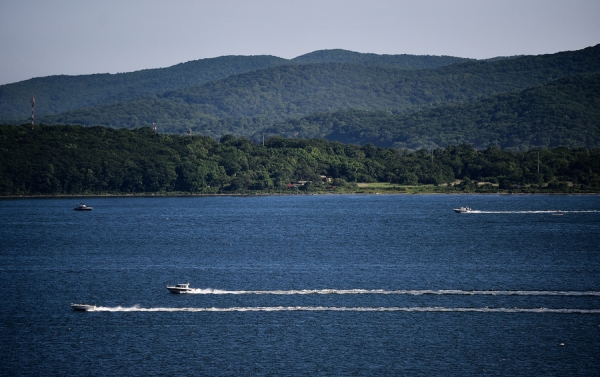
[0,195,600,376]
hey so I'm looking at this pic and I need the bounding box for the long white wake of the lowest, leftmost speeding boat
[88,306,600,314]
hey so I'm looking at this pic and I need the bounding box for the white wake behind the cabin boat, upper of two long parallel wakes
[188,288,600,296]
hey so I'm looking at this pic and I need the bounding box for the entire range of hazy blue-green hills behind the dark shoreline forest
[0,45,600,151]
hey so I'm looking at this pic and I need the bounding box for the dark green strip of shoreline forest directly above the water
[0,125,600,196]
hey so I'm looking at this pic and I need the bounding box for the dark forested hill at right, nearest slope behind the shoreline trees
[262,73,600,151]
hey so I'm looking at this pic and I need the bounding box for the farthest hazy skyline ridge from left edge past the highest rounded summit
[0,50,469,121]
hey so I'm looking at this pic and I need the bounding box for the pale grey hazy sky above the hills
[0,0,600,84]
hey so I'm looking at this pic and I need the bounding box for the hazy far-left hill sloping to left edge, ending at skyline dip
[0,56,288,120]
